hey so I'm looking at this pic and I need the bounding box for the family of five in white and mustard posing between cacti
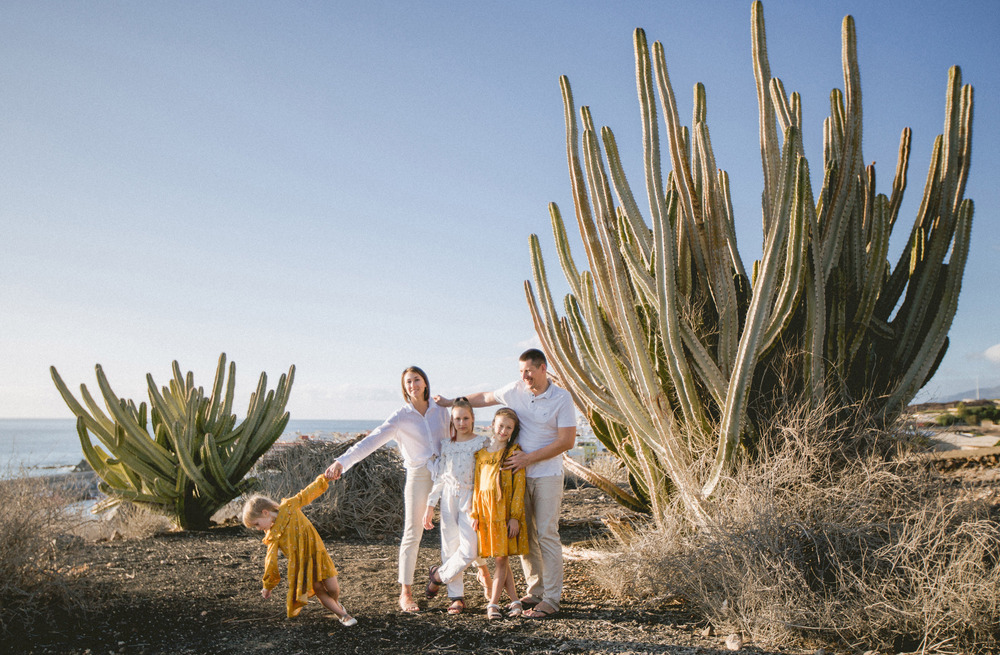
[243,349,576,626]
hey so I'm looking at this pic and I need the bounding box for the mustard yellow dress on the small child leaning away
[263,475,337,618]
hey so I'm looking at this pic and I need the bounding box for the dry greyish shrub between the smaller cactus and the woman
[251,436,406,539]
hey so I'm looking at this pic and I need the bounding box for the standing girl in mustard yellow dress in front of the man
[469,407,528,619]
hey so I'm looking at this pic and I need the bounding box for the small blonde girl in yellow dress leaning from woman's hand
[243,475,358,626]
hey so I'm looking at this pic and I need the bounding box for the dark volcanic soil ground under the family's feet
[17,488,811,655]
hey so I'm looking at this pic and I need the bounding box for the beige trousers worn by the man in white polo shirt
[521,473,563,609]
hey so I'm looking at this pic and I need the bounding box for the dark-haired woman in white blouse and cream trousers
[326,366,451,613]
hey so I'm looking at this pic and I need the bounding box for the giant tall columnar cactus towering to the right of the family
[525,2,972,522]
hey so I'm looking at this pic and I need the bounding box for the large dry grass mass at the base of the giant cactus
[597,408,1000,653]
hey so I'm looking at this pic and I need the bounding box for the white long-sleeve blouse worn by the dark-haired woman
[337,398,451,473]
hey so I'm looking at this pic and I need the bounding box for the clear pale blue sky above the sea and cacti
[0,0,1000,419]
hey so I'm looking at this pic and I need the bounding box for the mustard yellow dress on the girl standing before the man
[469,446,528,557]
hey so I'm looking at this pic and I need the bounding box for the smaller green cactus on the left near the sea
[50,353,295,530]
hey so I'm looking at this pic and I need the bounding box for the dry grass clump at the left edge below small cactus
[0,476,86,637]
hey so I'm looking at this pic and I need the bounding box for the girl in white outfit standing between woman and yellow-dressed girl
[424,398,490,614]
